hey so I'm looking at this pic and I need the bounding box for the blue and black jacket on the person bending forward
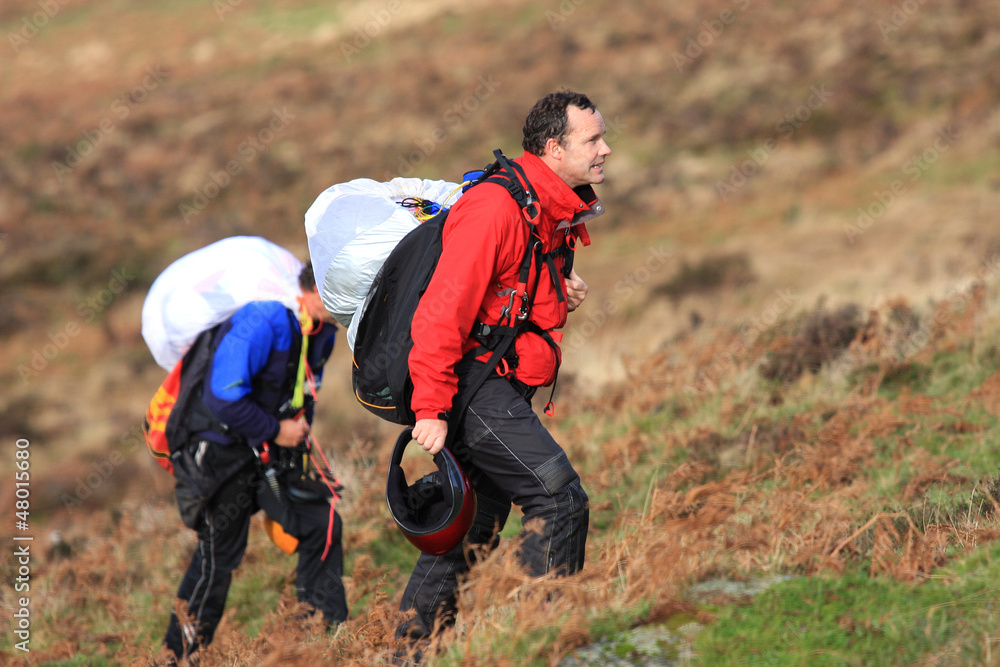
[199,301,337,446]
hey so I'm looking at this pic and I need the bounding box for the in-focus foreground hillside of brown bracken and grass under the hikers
[9,268,1000,665]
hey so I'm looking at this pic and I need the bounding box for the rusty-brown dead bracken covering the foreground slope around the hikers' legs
[5,288,1000,665]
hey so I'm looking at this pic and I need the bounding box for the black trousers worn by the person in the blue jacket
[164,463,347,657]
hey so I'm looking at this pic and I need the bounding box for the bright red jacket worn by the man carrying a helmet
[409,153,604,419]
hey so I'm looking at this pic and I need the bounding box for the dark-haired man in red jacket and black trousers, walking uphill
[398,91,611,652]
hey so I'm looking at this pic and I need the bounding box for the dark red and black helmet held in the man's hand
[385,428,476,556]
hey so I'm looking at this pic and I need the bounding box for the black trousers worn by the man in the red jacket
[397,365,589,638]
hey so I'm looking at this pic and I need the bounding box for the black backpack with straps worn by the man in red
[352,149,572,434]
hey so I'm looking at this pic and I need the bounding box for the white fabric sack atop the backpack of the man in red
[305,178,461,350]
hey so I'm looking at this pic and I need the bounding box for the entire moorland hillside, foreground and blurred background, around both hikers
[0,0,1000,665]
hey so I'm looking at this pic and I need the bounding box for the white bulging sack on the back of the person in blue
[142,236,302,370]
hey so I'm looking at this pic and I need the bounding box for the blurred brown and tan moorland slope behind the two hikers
[0,0,1000,536]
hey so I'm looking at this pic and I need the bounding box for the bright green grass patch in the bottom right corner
[694,543,1000,666]
